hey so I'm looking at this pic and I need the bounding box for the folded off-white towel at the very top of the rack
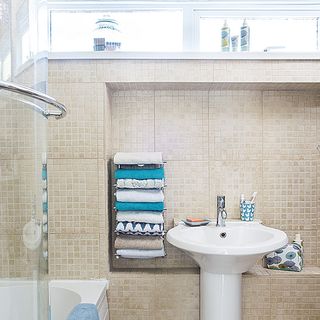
[114,152,163,164]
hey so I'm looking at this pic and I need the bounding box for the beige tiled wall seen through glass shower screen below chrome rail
[0,96,46,278]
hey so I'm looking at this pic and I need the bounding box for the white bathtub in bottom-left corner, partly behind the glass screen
[0,279,109,320]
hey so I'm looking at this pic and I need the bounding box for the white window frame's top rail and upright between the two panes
[48,0,320,53]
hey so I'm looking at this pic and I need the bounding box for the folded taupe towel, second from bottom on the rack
[114,235,163,250]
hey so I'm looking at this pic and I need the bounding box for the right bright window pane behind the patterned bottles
[199,17,318,52]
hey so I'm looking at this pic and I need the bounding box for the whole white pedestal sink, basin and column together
[167,221,288,320]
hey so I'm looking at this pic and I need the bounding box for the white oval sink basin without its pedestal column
[167,222,288,274]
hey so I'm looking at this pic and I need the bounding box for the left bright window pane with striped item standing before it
[50,10,183,52]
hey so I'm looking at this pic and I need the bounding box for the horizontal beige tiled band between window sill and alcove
[49,58,320,84]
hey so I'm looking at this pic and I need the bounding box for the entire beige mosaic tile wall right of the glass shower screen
[49,61,320,320]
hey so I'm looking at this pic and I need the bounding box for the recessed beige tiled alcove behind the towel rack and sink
[107,82,320,269]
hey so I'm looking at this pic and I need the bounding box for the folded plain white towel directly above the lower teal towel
[116,189,164,202]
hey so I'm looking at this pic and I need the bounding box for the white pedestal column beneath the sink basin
[200,270,242,320]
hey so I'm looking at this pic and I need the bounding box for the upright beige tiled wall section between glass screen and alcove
[48,81,108,279]
